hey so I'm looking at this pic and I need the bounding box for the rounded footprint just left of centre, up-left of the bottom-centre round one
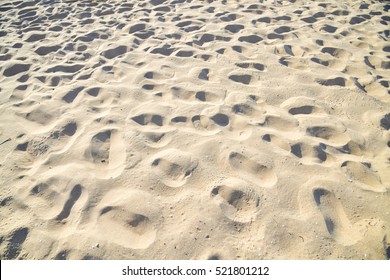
[151,149,198,188]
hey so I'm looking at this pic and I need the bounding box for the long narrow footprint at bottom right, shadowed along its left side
[313,188,359,246]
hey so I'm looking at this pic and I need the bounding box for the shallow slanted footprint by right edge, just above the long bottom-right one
[341,161,386,192]
